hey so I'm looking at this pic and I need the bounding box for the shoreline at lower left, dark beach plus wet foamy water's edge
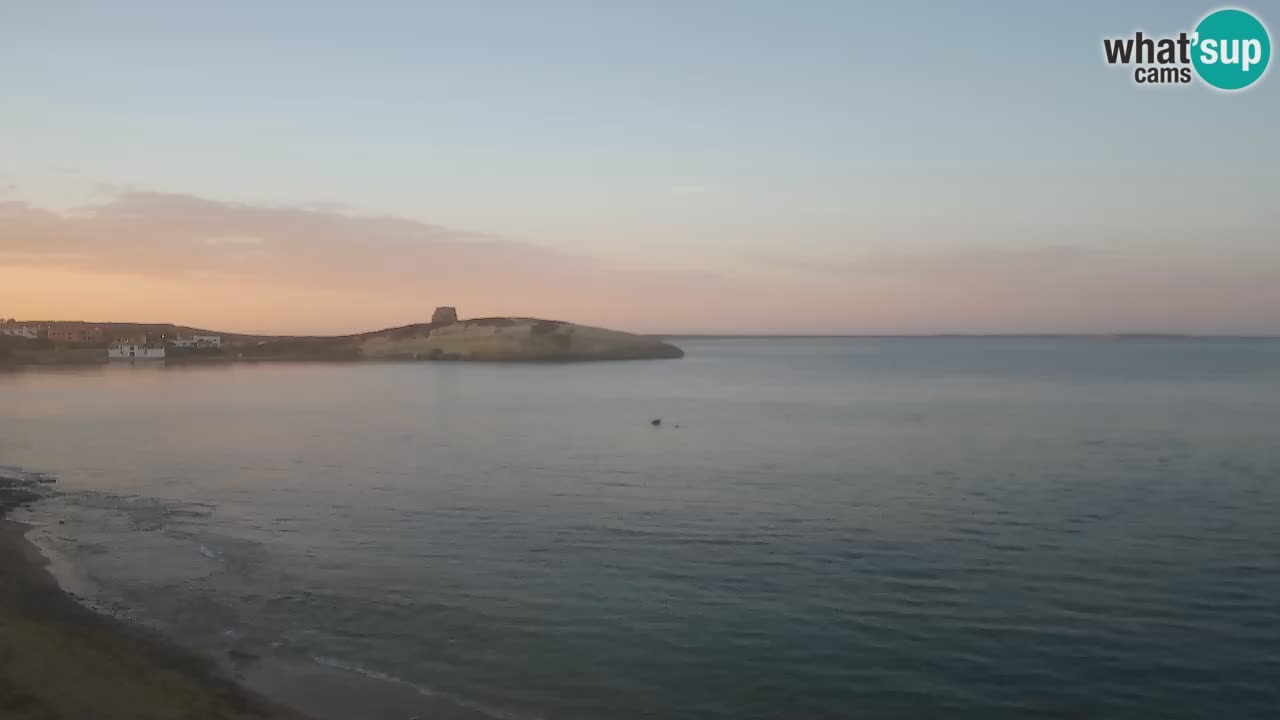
[0,476,517,720]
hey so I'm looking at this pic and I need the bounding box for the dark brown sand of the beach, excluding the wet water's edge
[0,479,303,720]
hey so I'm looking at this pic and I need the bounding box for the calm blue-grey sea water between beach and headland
[0,338,1280,720]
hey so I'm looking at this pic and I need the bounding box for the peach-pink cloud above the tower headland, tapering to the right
[0,192,739,329]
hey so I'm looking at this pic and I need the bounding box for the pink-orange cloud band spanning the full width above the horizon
[0,192,1280,333]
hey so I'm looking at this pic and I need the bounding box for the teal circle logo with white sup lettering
[1192,9,1271,90]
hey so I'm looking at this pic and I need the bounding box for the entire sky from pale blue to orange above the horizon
[0,0,1280,334]
